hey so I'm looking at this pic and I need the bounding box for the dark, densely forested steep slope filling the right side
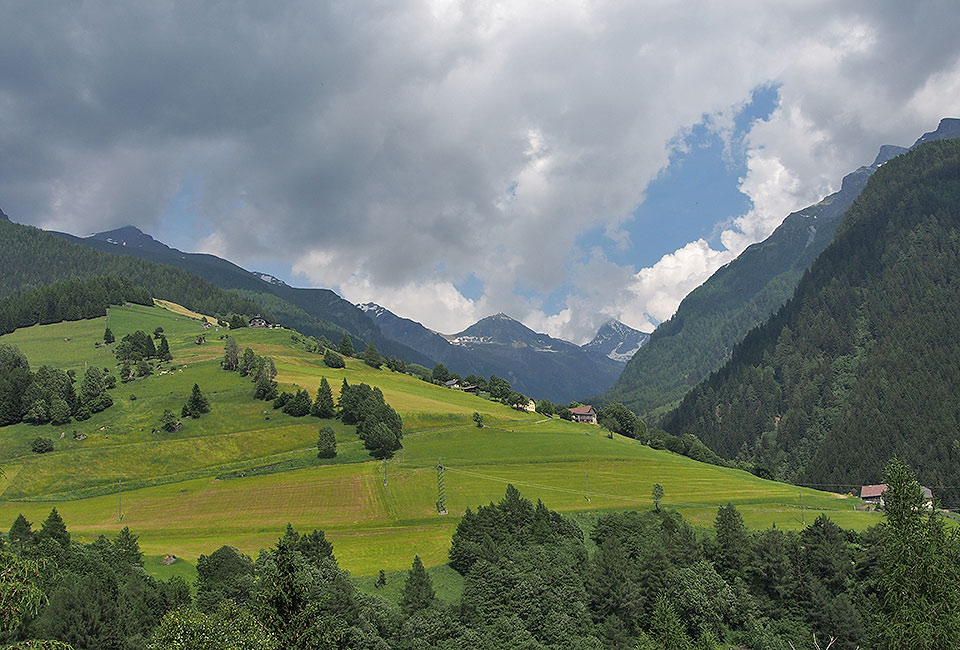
[663,135,960,506]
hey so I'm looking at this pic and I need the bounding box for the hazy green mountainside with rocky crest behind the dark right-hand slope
[597,118,960,420]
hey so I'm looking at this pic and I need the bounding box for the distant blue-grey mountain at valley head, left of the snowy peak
[360,303,624,403]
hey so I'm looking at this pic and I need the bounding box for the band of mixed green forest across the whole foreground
[0,461,960,650]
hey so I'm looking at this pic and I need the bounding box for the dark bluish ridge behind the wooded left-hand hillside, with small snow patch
[48,226,432,364]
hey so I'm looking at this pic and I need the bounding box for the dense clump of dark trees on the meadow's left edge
[0,344,116,426]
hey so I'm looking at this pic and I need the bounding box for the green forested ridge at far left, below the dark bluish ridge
[0,219,263,314]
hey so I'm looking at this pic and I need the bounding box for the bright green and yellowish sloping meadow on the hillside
[0,306,878,576]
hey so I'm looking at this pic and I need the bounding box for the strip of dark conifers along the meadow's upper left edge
[0,277,153,334]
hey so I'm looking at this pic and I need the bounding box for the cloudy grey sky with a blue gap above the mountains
[0,0,960,343]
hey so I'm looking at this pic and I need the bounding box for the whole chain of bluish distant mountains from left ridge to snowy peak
[0,215,647,403]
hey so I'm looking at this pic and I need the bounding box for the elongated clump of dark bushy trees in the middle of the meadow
[337,379,403,458]
